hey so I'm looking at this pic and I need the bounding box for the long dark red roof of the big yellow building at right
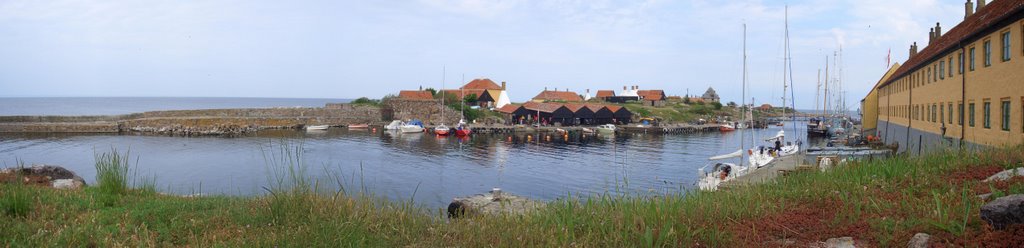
[879,0,1024,88]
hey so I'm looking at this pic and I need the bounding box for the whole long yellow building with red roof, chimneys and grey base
[876,0,1024,153]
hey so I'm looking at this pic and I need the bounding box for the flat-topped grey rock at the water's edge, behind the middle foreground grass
[447,190,544,217]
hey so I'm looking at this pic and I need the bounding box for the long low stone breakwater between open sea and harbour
[0,104,382,136]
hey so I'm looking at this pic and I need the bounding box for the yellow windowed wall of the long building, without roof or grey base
[865,20,1024,147]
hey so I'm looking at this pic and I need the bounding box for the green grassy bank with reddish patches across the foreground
[0,144,1024,247]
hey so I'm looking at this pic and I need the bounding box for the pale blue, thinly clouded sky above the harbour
[0,0,964,109]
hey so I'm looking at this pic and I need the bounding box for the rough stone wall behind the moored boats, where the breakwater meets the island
[381,98,462,126]
